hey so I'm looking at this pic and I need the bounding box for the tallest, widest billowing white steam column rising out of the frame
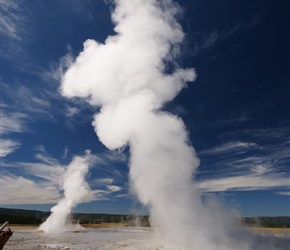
[61,0,286,250]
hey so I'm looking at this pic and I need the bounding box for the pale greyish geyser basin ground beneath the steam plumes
[5,226,290,250]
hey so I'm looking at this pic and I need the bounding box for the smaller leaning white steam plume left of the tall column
[39,151,94,233]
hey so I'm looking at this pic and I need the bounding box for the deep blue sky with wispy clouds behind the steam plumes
[1,0,290,216]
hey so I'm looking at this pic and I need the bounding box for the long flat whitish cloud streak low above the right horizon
[198,175,290,192]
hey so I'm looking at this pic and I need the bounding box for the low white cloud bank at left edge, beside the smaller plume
[1,150,65,204]
